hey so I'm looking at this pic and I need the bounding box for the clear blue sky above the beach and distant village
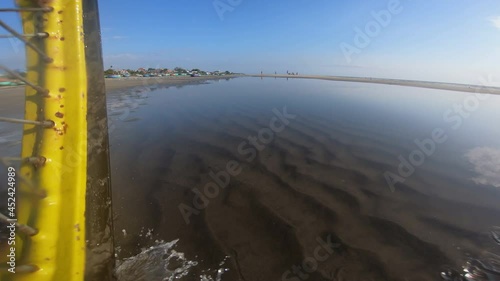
[0,0,500,84]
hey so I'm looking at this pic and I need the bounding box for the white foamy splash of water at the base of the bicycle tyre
[116,239,228,281]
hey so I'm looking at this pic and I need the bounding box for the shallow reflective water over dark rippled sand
[108,78,500,280]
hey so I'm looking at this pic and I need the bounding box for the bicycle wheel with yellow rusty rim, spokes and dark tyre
[0,0,115,281]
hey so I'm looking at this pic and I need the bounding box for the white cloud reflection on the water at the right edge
[465,147,500,187]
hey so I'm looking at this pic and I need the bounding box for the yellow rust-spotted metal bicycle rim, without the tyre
[12,0,88,281]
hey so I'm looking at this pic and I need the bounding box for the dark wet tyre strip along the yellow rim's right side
[82,0,116,281]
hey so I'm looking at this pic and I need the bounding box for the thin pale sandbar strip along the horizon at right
[243,74,500,95]
